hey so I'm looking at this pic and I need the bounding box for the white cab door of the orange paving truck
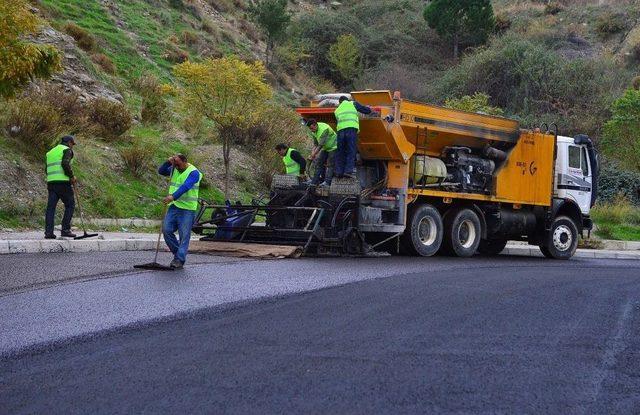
[558,144,592,215]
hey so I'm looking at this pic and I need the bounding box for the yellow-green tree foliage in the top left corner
[0,0,62,97]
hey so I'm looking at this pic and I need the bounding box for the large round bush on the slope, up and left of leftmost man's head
[5,97,66,157]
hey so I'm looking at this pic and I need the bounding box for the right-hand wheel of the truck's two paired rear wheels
[443,209,481,258]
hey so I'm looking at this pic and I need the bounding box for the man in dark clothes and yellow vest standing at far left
[44,135,76,239]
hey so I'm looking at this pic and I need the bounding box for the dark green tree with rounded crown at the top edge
[424,0,495,59]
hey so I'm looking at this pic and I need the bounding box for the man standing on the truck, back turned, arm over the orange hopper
[334,95,373,178]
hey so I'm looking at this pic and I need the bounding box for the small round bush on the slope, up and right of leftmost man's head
[89,98,133,140]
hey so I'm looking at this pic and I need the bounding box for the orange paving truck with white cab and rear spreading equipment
[194,91,598,259]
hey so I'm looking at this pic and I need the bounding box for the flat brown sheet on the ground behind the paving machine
[189,241,302,259]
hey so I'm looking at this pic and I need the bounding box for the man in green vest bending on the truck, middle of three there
[306,118,338,186]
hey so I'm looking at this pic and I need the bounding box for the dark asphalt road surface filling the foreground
[0,259,640,414]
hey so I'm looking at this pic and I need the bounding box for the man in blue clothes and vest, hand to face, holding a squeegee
[158,154,202,269]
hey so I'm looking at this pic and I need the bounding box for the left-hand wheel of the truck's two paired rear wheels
[400,204,443,256]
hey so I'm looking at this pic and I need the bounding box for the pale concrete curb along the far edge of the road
[0,239,640,260]
